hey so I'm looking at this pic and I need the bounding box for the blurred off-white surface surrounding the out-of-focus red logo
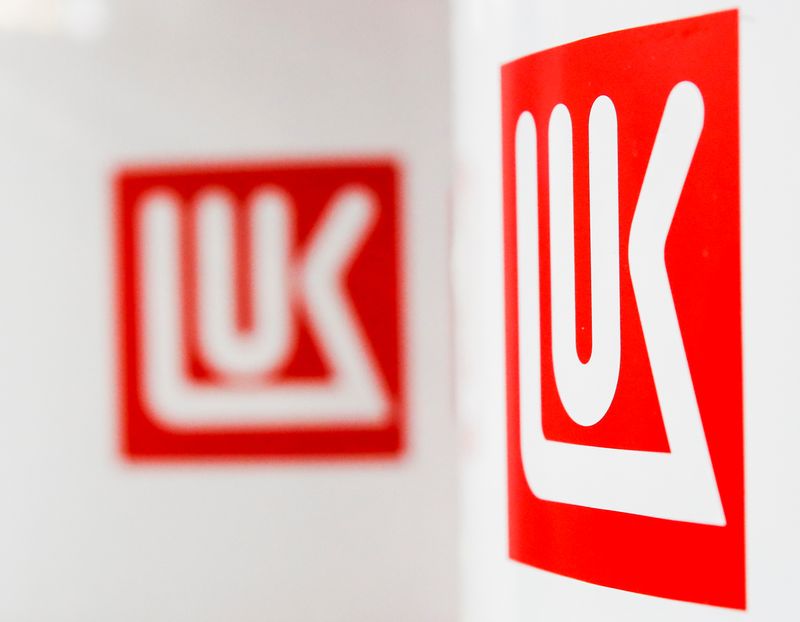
[0,0,456,622]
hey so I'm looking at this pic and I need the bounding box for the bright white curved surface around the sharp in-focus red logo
[453,0,800,622]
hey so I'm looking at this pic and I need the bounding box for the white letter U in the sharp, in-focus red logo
[548,96,621,426]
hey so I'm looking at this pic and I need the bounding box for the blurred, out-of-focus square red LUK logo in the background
[117,162,402,457]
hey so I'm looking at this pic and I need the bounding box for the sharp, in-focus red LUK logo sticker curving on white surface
[502,11,745,608]
